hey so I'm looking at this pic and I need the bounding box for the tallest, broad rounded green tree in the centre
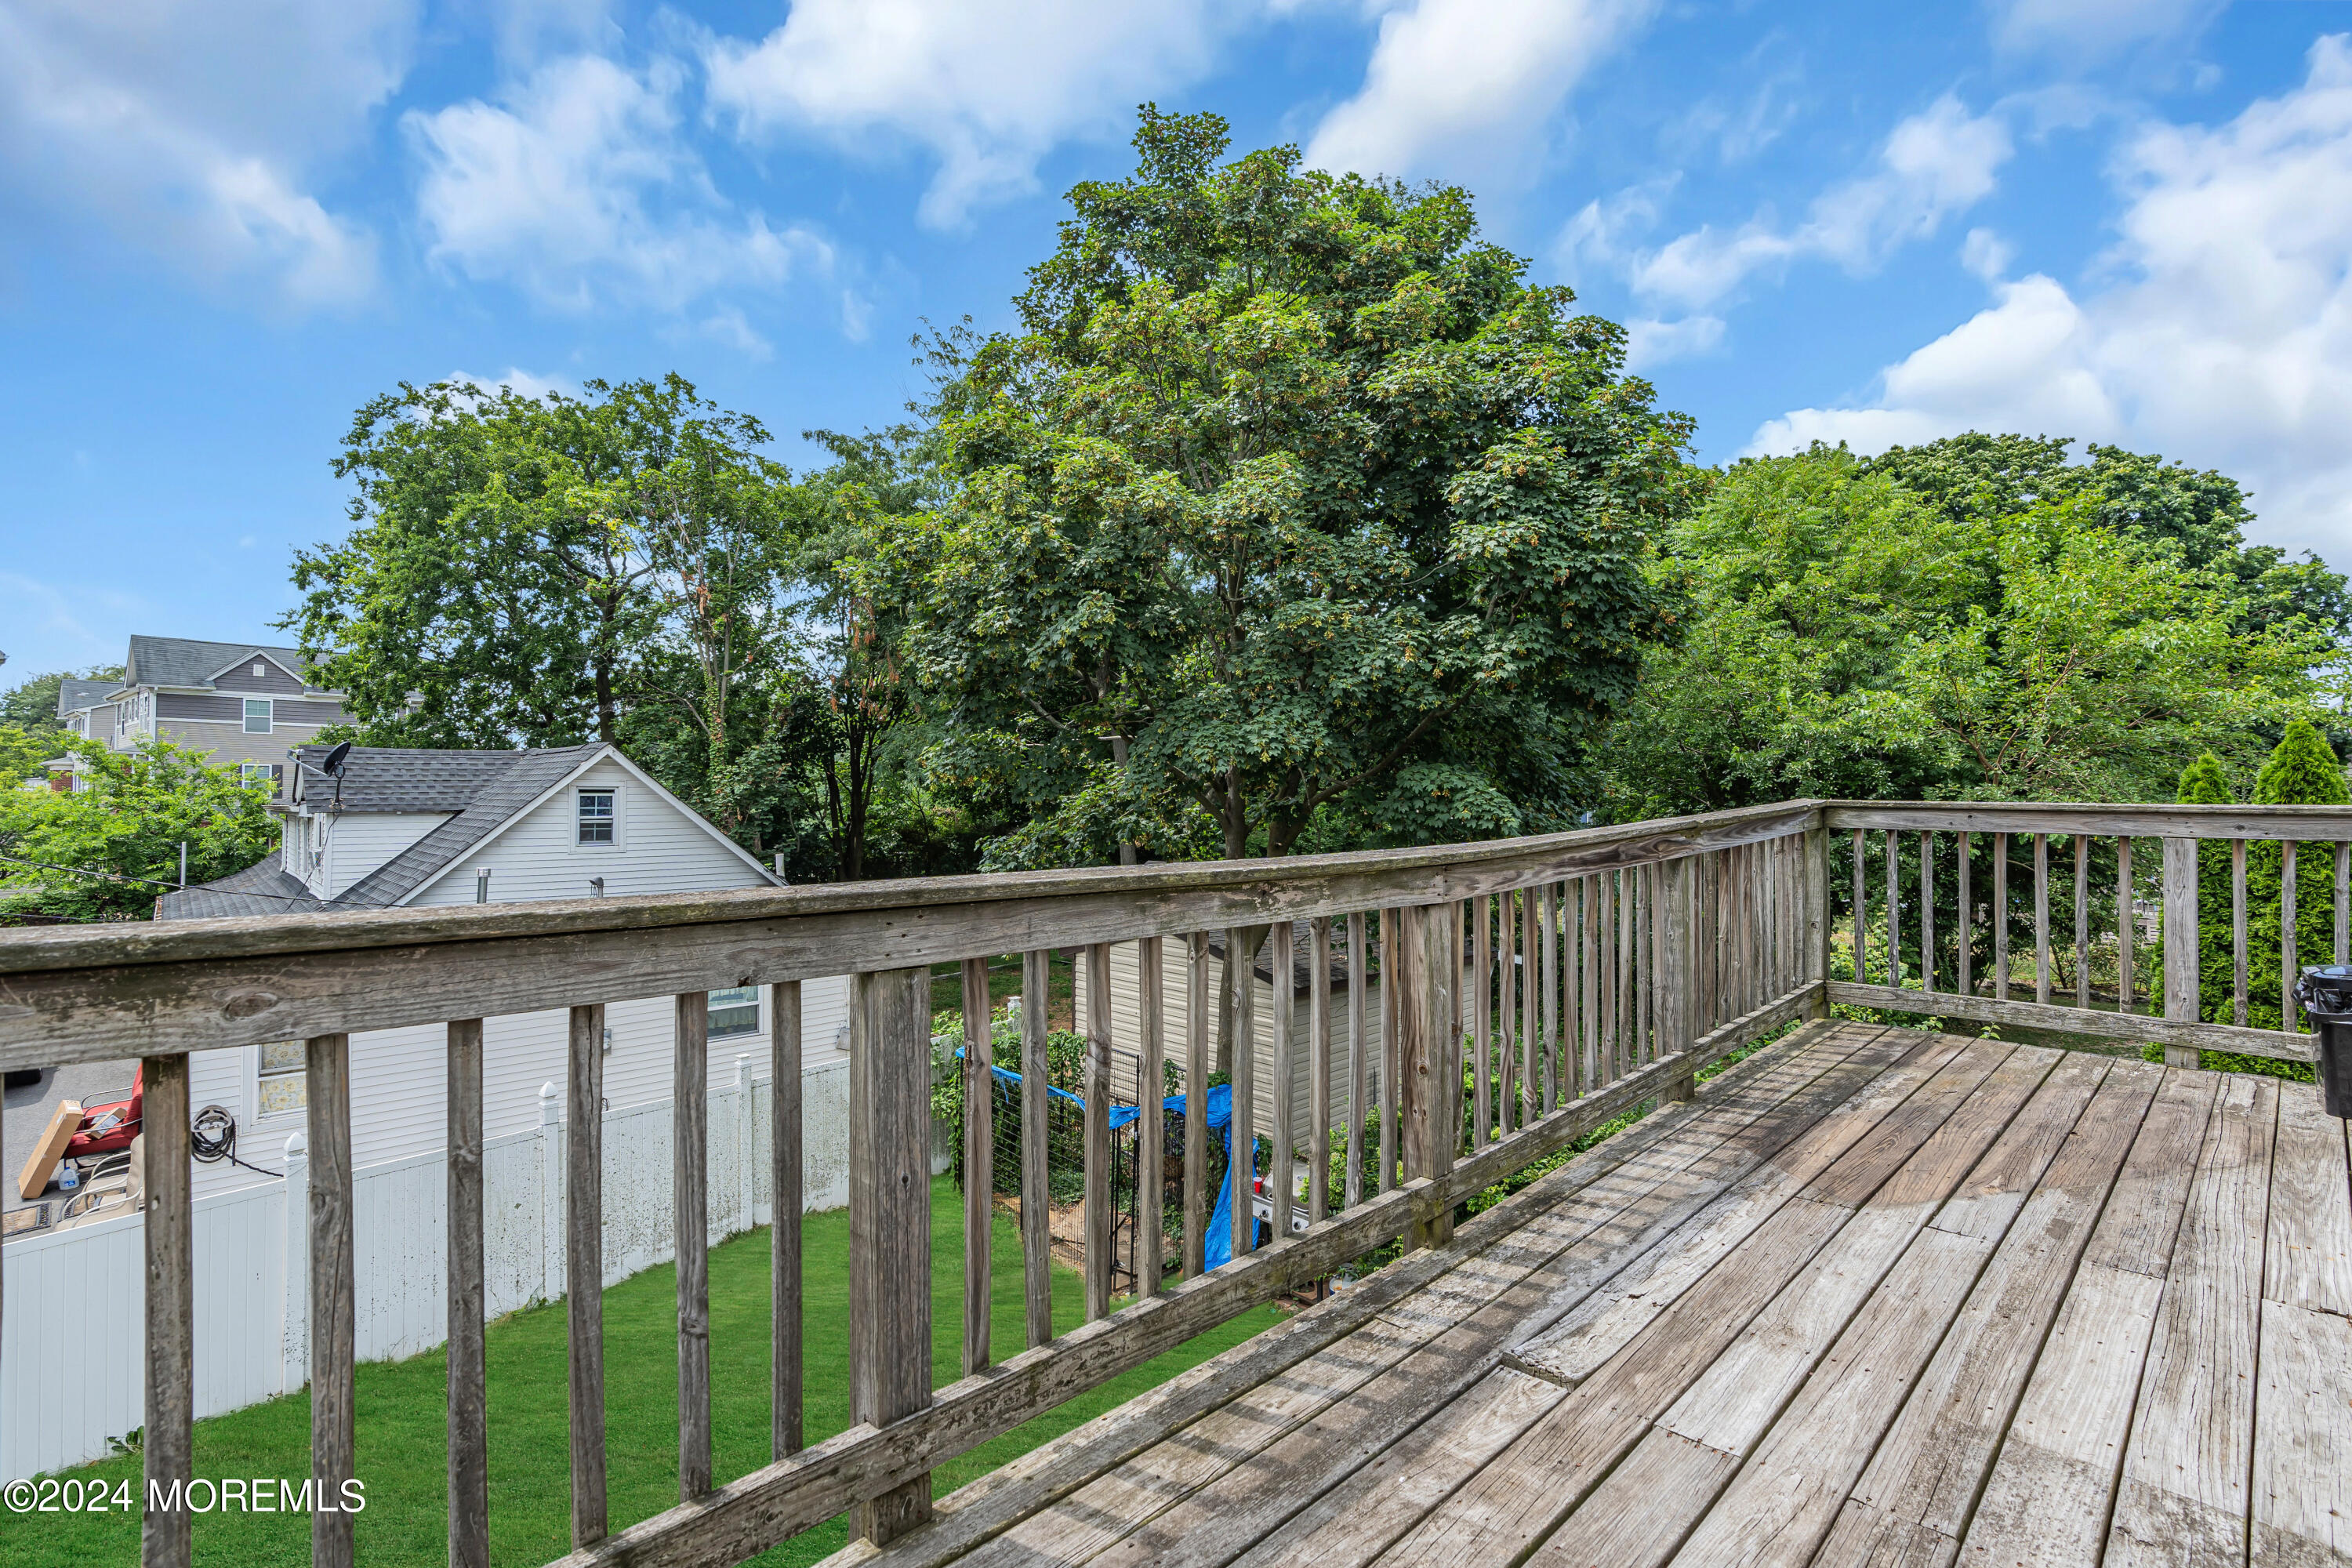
[856,108,1689,865]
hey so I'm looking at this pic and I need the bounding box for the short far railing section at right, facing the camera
[1825,801,2352,1067]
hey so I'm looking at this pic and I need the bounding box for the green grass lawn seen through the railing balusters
[0,1180,1275,1568]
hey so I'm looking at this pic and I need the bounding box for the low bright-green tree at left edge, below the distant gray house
[0,736,278,919]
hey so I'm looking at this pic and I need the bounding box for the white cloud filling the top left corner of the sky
[0,0,416,308]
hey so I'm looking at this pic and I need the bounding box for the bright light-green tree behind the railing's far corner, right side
[1609,447,2336,815]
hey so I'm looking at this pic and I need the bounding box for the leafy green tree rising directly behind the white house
[287,374,790,825]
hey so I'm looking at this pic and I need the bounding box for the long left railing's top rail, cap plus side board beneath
[0,801,1820,1067]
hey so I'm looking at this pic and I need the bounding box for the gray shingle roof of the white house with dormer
[155,741,607,919]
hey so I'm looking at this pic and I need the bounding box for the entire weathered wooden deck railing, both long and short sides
[18,801,2352,1566]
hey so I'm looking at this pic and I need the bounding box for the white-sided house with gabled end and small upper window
[155,743,849,1199]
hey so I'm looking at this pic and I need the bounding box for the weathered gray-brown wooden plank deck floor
[833,1022,2352,1568]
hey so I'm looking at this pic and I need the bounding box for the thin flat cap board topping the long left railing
[0,799,1823,973]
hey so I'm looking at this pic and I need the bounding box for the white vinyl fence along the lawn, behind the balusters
[0,1055,880,1481]
